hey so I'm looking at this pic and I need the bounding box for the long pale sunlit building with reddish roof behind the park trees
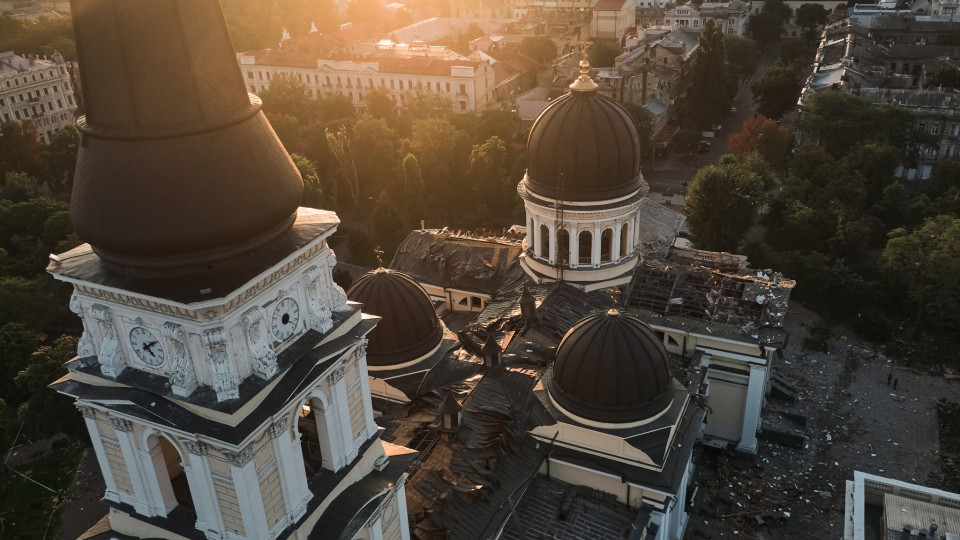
[238,39,496,112]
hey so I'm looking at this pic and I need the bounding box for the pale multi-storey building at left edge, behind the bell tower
[0,51,77,143]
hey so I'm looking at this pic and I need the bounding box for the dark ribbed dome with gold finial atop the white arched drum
[526,60,647,202]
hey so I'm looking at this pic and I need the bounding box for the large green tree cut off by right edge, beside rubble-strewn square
[880,216,960,329]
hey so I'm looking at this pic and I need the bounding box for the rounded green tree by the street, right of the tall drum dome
[684,158,763,251]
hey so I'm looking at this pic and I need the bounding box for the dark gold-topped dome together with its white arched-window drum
[517,60,649,291]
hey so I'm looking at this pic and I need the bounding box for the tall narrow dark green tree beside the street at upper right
[686,19,737,129]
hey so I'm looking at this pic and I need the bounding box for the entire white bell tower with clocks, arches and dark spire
[48,0,409,540]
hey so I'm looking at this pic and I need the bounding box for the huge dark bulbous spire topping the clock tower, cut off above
[70,0,303,275]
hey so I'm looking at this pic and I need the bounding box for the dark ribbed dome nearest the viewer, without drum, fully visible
[548,309,673,424]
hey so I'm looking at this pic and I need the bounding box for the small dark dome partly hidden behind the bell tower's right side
[347,268,443,367]
